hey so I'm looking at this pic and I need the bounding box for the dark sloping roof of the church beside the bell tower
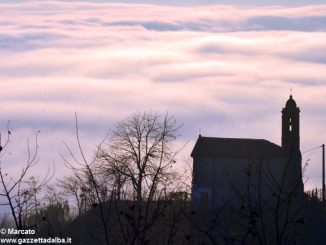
[191,136,284,157]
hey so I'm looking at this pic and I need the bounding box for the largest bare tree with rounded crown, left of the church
[97,112,180,201]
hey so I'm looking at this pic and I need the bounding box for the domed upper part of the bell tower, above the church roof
[282,95,300,153]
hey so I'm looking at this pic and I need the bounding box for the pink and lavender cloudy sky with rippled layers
[0,0,326,195]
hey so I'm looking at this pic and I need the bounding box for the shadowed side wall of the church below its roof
[193,157,297,211]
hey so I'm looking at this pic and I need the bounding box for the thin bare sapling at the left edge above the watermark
[0,123,54,234]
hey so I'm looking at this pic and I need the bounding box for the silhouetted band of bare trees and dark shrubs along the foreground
[0,112,326,245]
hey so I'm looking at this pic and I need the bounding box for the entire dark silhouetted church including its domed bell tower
[191,95,303,210]
